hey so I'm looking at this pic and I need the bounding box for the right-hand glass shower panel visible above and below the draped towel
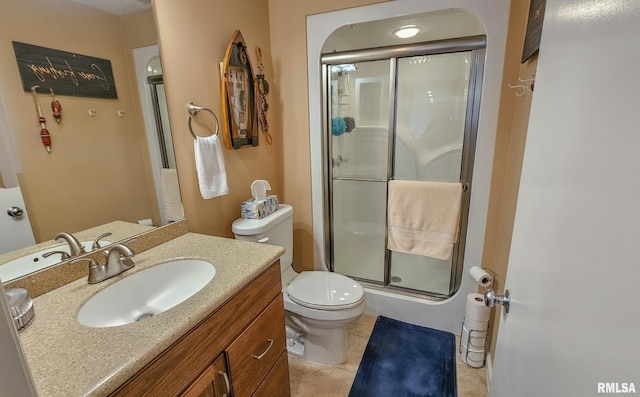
[389,51,471,295]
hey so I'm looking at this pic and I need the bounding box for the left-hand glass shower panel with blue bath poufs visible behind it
[330,59,391,283]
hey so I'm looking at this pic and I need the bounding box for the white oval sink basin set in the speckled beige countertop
[78,259,216,328]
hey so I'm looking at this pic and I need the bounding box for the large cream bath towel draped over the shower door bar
[387,180,462,260]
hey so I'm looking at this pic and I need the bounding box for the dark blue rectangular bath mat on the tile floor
[349,317,457,397]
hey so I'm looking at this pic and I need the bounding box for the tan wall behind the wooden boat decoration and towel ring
[154,0,284,237]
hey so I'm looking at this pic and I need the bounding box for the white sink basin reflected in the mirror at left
[0,240,111,282]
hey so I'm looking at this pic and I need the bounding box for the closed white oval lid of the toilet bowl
[287,271,364,310]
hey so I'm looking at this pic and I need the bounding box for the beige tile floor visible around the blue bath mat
[289,314,489,397]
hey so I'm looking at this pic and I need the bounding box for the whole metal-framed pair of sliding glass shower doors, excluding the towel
[322,36,485,298]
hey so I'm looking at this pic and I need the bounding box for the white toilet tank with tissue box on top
[231,204,293,269]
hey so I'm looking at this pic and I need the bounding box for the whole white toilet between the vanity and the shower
[232,204,365,365]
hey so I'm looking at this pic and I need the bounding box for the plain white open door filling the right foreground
[490,0,640,397]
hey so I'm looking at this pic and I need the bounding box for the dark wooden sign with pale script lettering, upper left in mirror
[13,41,118,99]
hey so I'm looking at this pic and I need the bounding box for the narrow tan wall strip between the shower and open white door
[479,1,537,357]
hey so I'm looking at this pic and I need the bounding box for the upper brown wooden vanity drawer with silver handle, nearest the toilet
[227,295,285,397]
